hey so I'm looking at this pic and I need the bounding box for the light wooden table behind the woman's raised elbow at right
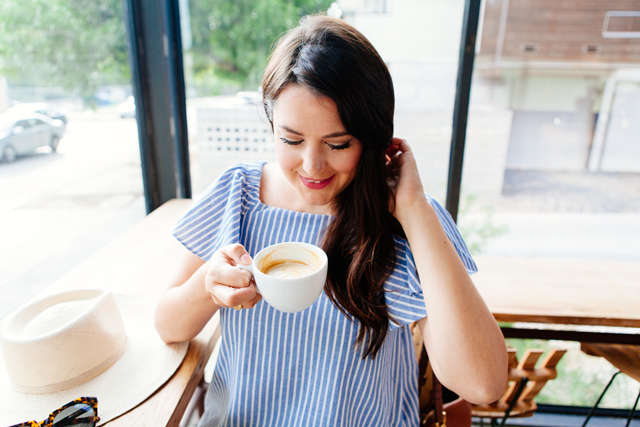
[472,256,640,344]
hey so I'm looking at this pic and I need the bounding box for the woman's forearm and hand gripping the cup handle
[155,245,262,344]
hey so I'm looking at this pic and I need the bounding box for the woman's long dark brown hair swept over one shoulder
[262,15,404,358]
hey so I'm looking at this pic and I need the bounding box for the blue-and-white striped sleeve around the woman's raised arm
[384,196,478,329]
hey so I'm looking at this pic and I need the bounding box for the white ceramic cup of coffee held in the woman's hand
[237,242,328,313]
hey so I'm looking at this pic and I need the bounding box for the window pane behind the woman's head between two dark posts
[181,0,463,201]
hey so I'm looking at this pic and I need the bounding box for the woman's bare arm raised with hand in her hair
[388,139,507,403]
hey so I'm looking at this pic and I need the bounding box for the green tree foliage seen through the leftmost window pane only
[0,0,130,96]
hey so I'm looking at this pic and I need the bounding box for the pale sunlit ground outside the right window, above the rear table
[459,170,640,261]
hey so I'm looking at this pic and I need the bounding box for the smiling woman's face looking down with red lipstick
[273,85,362,213]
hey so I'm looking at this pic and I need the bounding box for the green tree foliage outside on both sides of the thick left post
[0,0,332,97]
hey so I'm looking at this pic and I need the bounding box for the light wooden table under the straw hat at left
[39,200,219,427]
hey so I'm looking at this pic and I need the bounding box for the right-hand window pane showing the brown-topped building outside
[459,0,640,408]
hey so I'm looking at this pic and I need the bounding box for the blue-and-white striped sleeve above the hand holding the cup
[173,165,247,261]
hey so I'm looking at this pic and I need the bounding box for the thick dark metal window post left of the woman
[123,0,191,213]
